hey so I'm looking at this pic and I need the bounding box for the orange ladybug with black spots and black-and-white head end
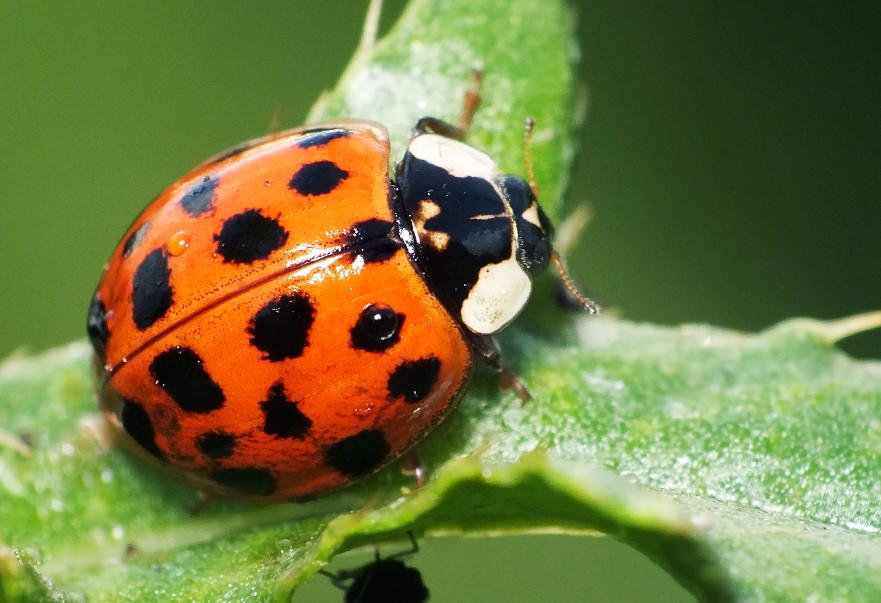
[88,98,592,500]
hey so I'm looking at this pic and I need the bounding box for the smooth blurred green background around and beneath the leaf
[0,0,881,602]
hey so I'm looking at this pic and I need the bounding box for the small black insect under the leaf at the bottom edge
[319,532,431,603]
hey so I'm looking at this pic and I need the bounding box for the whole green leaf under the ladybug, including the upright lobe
[0,0,881,603]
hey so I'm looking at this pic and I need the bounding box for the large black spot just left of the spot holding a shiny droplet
[248,292,315,362]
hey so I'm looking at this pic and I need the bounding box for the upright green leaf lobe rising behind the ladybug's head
[308,0,581,218]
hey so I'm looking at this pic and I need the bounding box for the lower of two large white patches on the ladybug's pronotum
[461,257,532,335]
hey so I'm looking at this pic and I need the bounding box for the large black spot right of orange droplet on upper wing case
[214,209,288,264]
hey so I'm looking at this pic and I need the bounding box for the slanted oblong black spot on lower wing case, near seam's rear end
[150,346,226,413]
